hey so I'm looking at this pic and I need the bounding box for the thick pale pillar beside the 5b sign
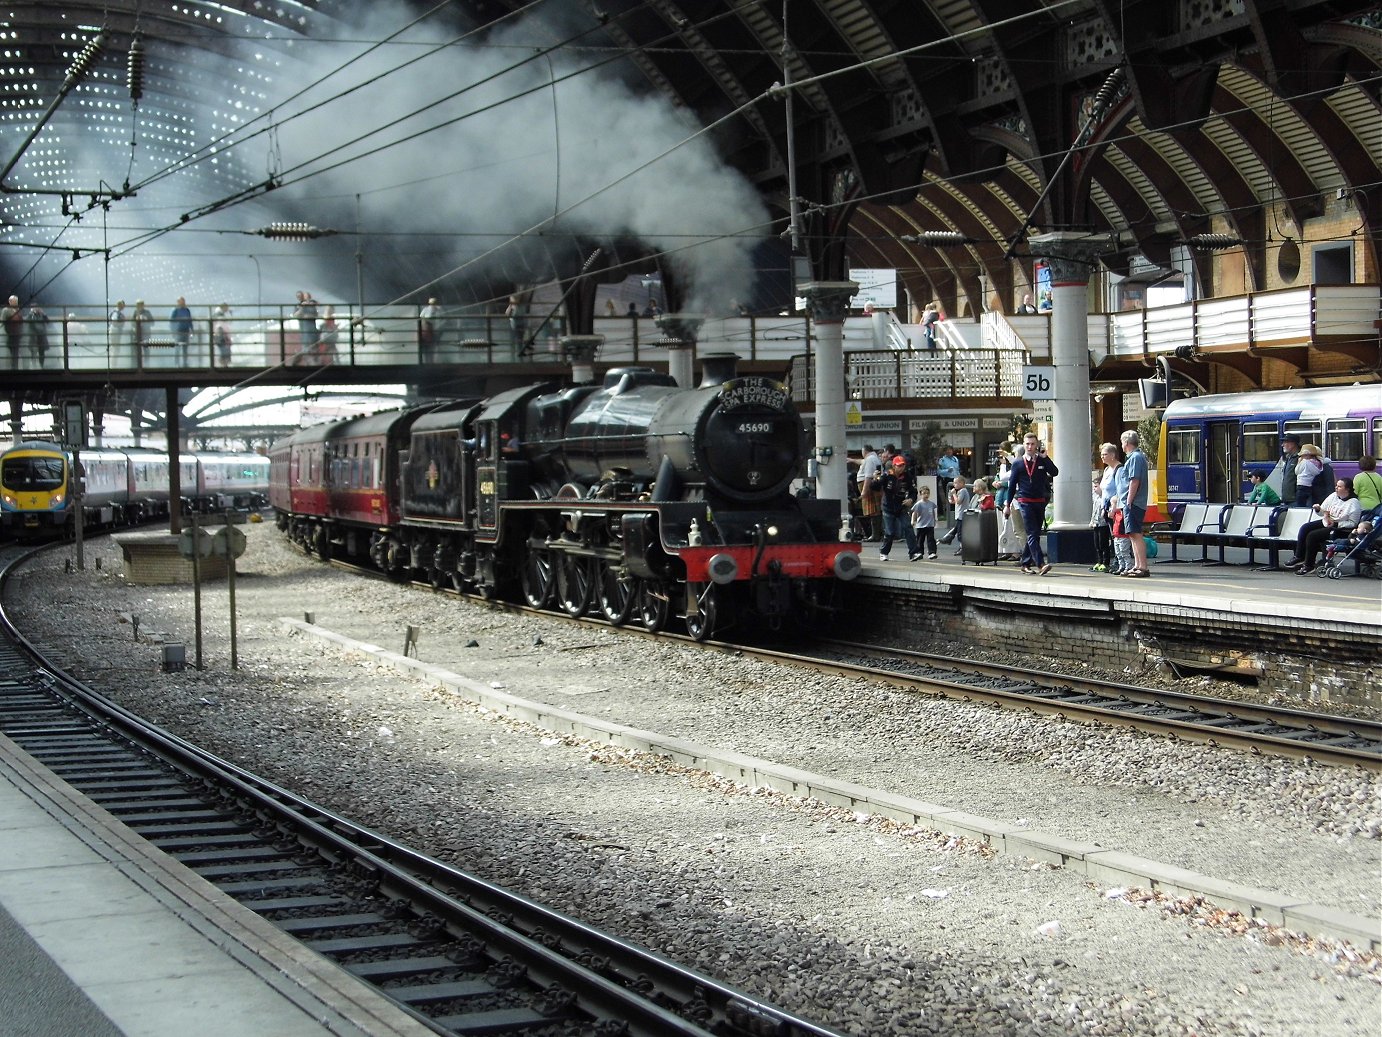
[1028,231,1113,563]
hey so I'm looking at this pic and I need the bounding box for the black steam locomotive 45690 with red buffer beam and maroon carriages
[269,355,860,639]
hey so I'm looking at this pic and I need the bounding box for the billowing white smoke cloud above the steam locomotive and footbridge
[43,4,768,311]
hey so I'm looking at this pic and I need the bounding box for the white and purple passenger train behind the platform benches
[1158,384,1382,514]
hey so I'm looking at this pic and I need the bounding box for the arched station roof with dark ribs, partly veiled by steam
[0,0,1382,311]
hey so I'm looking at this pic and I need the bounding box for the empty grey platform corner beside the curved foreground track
[0,736,434,1037]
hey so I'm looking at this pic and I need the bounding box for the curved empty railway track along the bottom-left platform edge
[0,550,832,1037]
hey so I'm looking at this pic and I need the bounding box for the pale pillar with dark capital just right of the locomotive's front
[797,281,860,523]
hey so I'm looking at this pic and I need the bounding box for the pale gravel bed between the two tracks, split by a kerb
[6,524,1382,1037]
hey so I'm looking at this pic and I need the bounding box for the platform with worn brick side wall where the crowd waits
[843,530,1382,715]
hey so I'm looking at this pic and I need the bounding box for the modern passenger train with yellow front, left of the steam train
[0,441,268,538]
